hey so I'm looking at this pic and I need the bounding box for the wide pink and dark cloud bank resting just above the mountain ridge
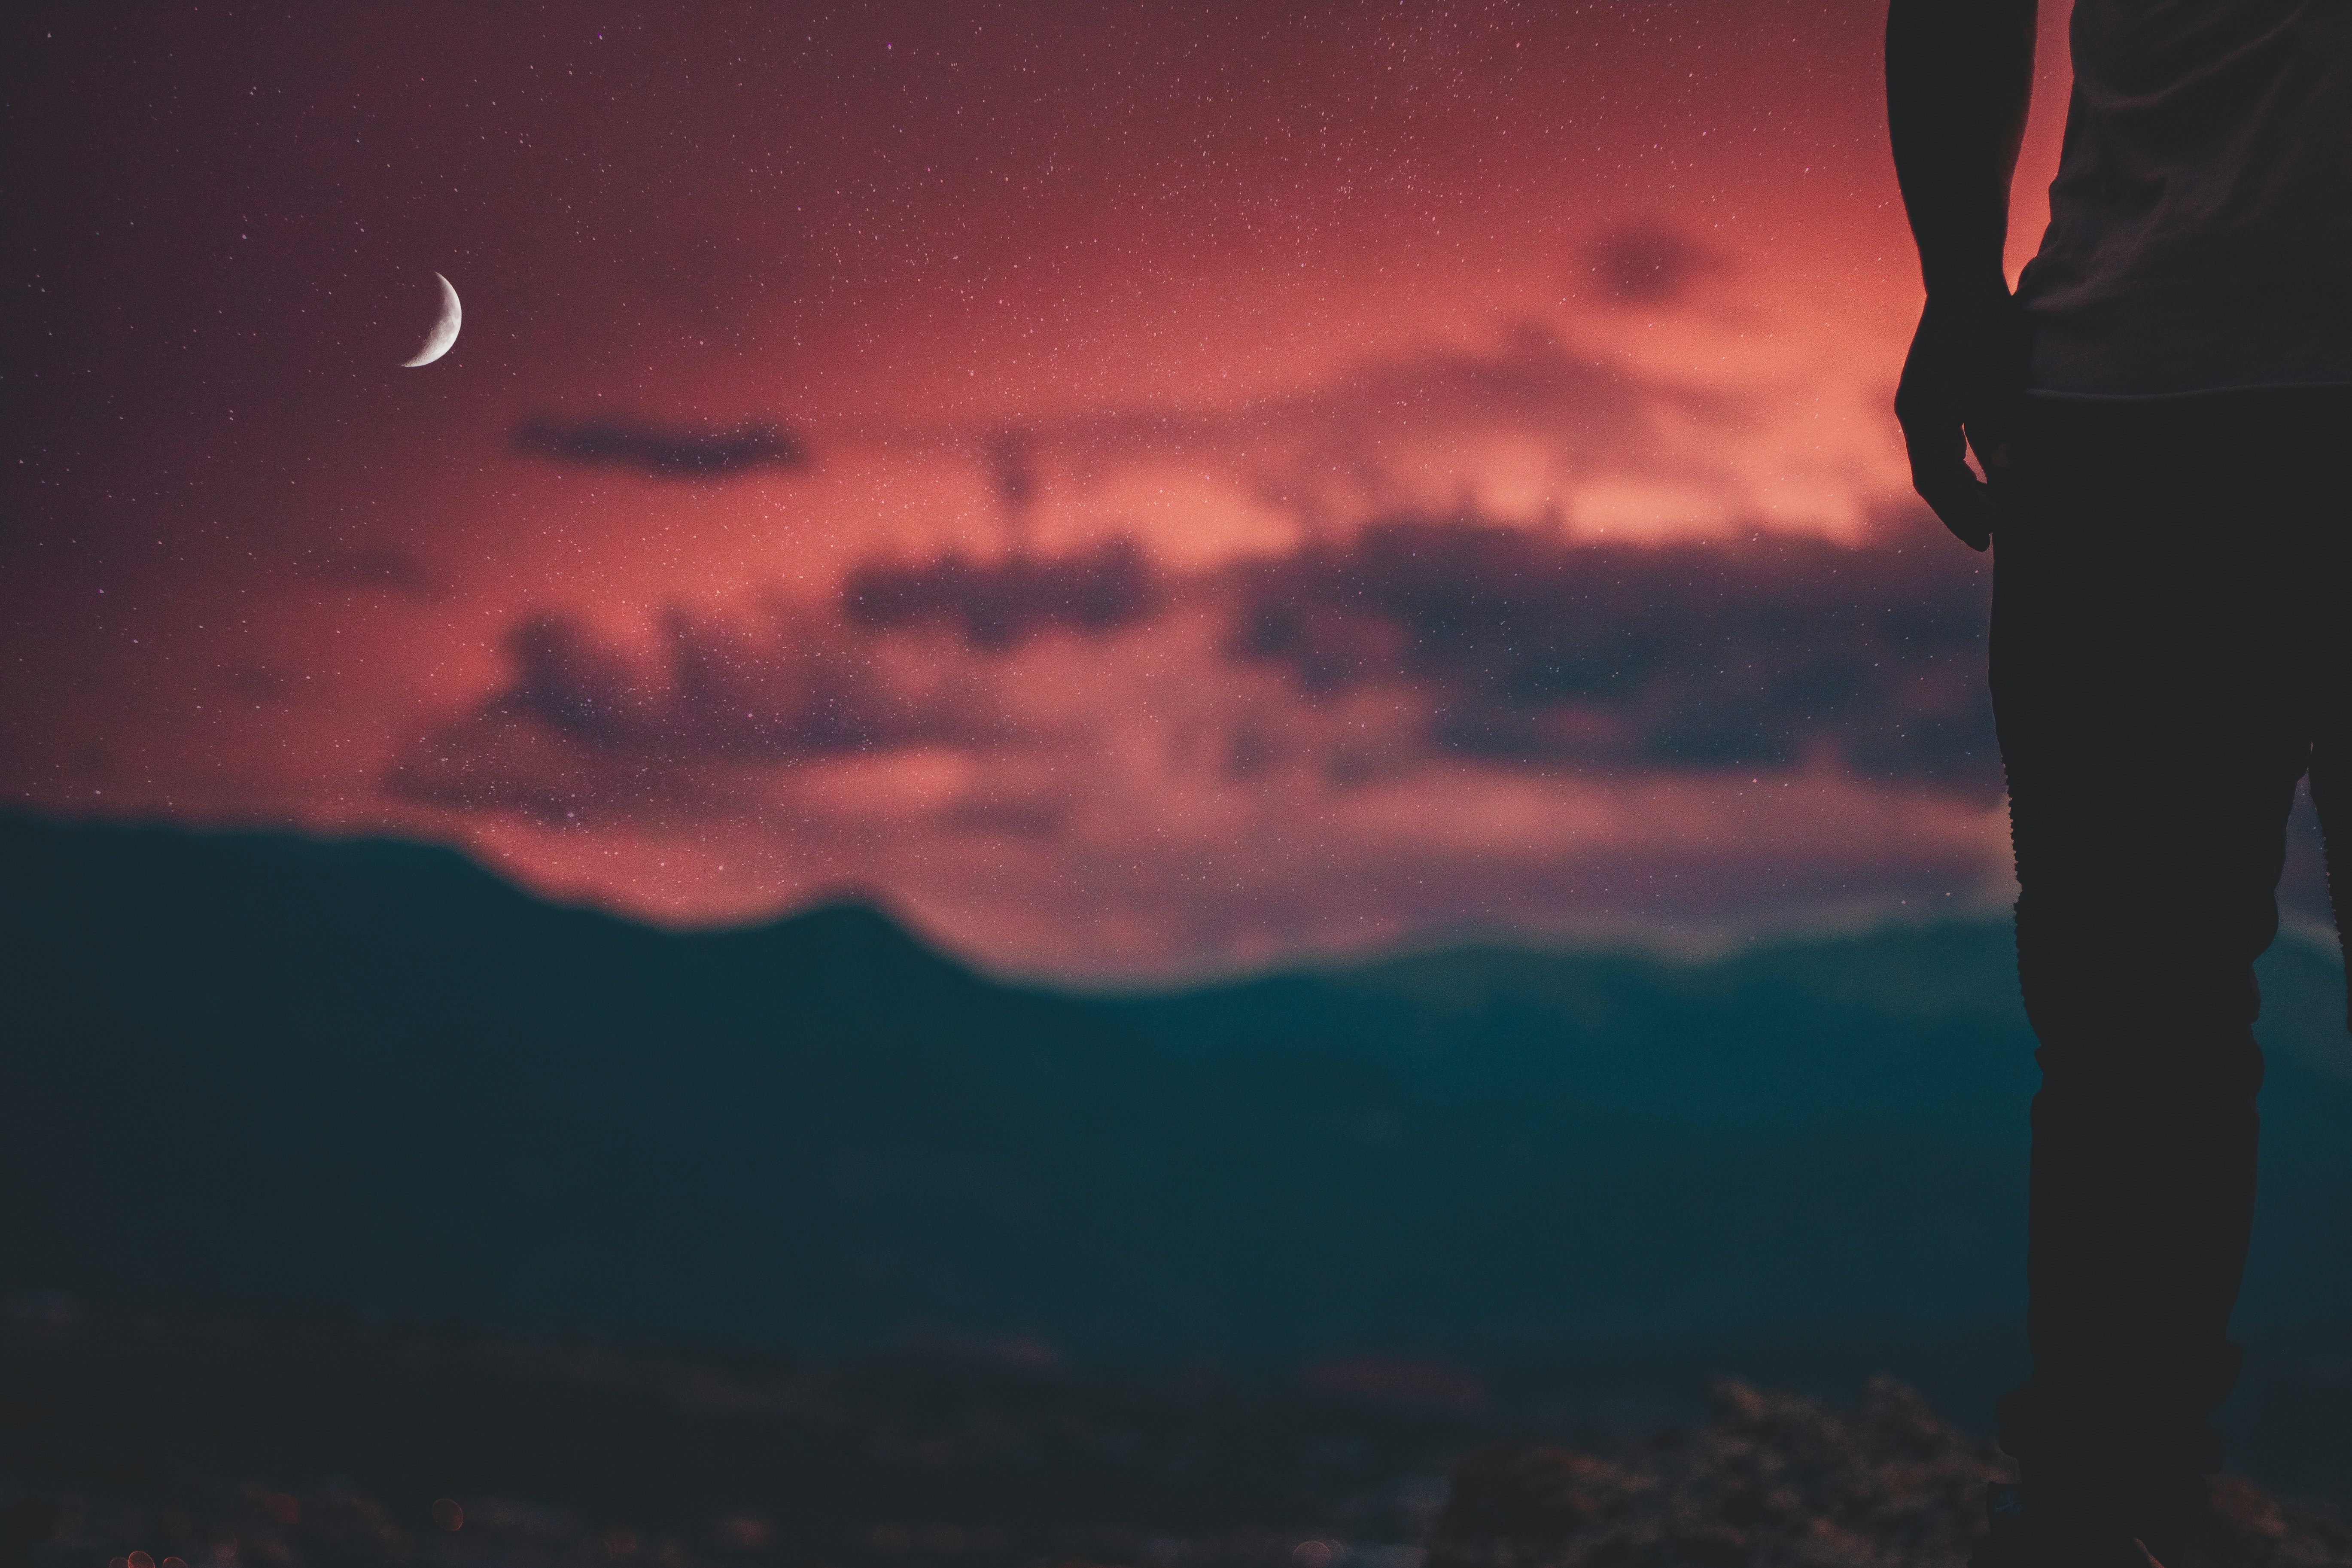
[371,510,2006,976]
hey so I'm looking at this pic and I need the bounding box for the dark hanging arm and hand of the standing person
[1886,0,2035,550]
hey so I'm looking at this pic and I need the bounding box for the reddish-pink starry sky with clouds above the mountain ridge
[23,0,2295,983]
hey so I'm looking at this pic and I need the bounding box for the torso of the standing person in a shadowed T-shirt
[2018,0,2352,395]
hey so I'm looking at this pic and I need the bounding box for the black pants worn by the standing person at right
[1992,388,2352,1556]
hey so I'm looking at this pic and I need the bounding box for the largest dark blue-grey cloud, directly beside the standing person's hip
[1230,517,1999,792]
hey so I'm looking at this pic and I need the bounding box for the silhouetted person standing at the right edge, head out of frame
[1886,0,2352,1568]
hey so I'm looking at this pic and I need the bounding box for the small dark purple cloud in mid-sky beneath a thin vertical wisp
[842,538,1162,649]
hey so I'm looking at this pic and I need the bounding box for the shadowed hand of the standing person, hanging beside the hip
[1896,284,2027,550]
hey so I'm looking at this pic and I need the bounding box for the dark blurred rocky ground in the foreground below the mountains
[0,1312,2352,1568]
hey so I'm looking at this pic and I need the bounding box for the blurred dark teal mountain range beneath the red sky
[0,818,2352,1361]
